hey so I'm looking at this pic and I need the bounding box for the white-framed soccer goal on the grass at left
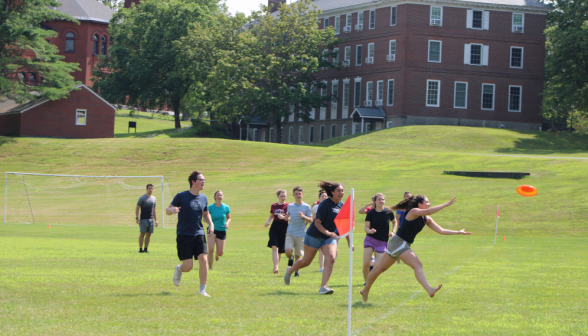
[4,172,175,228]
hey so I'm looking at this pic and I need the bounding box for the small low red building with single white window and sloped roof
[0,85,115,138]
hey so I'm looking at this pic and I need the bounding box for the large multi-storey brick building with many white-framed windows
[258,0,551,144]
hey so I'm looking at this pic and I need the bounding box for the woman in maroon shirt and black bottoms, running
[265,189,288,273]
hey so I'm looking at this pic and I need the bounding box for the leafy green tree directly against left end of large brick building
[208,0,341,140]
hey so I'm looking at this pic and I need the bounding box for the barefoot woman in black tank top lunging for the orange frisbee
[360,195,472,302]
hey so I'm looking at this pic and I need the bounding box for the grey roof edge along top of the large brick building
[319,0,554,18]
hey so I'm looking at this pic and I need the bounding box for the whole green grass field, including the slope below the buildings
[0,126,588,335]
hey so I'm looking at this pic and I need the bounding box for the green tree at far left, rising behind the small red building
[0,0,80,103]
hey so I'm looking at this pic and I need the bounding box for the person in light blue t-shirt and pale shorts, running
[278,186,312,276]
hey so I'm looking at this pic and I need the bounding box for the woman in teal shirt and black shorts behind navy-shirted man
[208,190,231,269]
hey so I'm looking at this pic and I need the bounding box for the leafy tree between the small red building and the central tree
[93,0,219,128]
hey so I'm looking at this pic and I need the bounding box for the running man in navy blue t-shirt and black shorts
[166,170,214,297]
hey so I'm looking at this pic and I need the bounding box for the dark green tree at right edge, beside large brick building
[542,0,588,131]
